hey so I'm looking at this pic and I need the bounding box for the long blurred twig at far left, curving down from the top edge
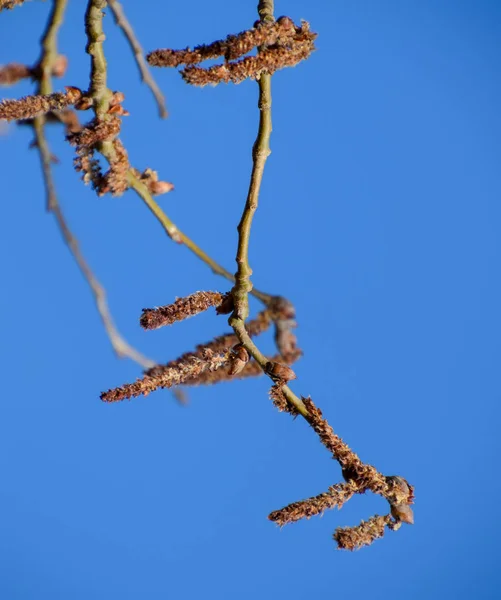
[33,0,156,369]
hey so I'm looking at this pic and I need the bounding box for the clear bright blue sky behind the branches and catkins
[0,0,501,600]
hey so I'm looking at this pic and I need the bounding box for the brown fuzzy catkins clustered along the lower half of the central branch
[101,292,414,550]
